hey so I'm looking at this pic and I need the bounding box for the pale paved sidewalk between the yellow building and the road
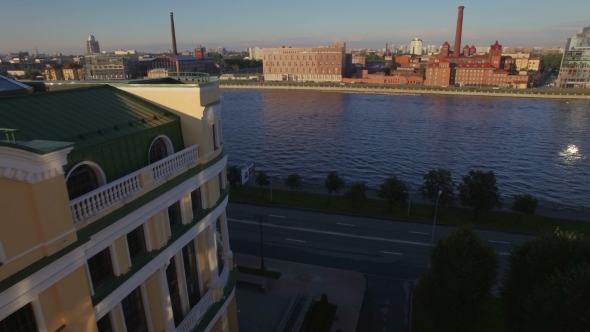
[234,253,366,332]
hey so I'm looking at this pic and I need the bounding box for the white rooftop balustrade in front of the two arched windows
[70,145,199,223]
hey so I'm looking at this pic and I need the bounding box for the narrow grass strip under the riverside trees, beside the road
[230,187,590,235]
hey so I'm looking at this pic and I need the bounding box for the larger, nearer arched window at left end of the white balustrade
[66,162,105,200]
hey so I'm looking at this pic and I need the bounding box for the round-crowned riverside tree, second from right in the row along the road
[459,170,502,220]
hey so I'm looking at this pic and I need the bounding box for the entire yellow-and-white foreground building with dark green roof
[0,78,238,332]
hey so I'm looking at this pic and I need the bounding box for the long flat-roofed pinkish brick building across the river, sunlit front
[262,42,346,82]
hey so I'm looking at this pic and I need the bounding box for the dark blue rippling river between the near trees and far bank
[222,89,590,207]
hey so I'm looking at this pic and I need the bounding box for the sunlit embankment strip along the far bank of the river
[220,82,590,100]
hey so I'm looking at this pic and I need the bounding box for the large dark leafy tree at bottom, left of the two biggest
[414,226,500,332]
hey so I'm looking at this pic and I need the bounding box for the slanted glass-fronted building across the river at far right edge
[556,27,590,89]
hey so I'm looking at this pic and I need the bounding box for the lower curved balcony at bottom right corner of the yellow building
[176,264,237,332]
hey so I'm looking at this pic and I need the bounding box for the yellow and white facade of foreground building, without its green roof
[0,78,238,332]
